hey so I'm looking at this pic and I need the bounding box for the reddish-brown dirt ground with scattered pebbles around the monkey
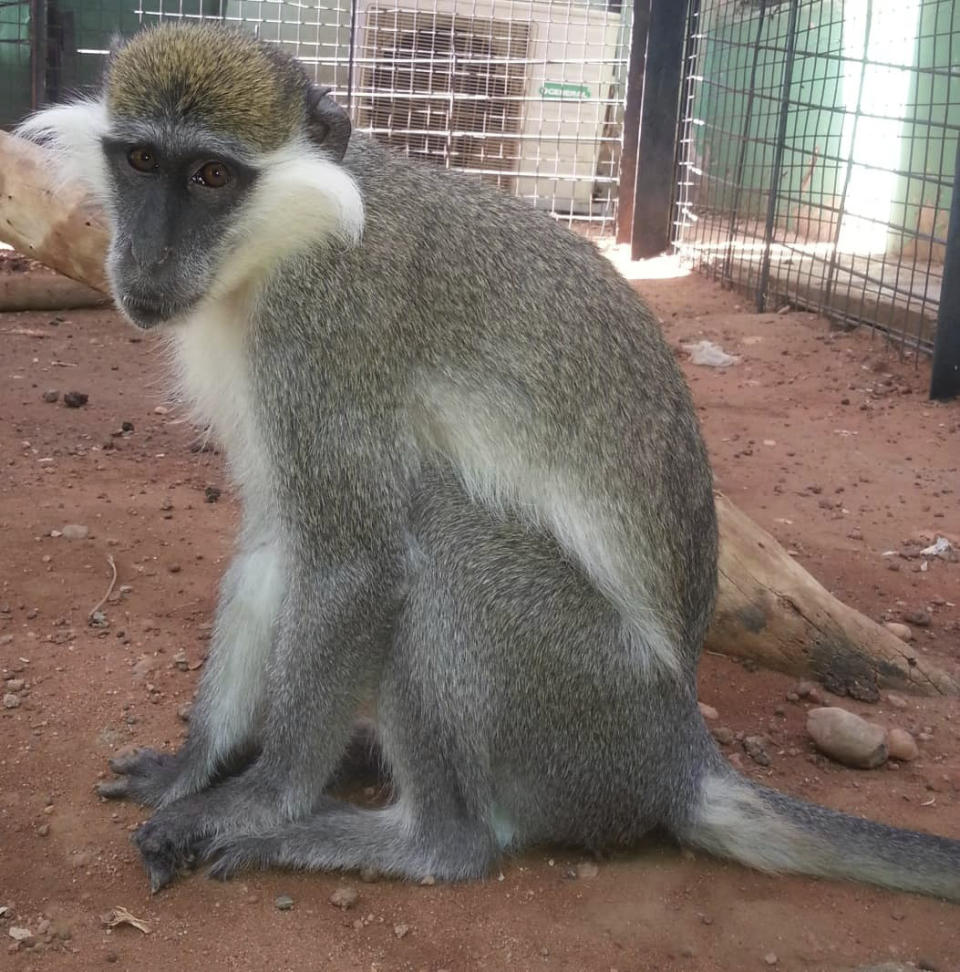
[0,260,960,972]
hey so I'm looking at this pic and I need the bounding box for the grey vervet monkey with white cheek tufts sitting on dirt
[22,24,960,900]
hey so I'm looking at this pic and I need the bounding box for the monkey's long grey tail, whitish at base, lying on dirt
[678,767,960,901]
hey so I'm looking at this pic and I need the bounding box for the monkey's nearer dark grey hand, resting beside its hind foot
[133,768,287,891]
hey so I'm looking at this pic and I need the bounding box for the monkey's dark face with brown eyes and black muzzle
[102,122,257,328]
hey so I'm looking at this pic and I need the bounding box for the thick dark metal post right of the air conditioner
[631,0,689,260]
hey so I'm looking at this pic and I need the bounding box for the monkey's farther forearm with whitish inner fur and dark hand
[98,540,283,807]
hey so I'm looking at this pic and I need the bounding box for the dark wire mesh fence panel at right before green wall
[675,0,960,349]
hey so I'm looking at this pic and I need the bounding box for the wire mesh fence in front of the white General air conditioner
[0,0,632,234]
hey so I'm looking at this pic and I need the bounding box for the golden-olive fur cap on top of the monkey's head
[106,23,308,151]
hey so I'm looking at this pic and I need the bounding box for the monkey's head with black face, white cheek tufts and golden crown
[20,23,363,328]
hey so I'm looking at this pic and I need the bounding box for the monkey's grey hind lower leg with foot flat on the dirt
[204,552,501,880]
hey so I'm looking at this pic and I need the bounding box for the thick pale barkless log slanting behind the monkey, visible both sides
[0,132,960,701]
